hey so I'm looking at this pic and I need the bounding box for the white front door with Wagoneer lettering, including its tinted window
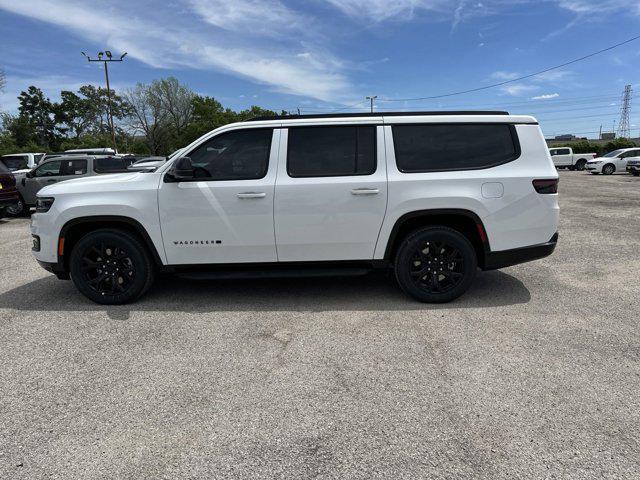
[158,128,280,265]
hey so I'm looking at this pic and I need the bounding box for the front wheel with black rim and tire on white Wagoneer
[69,229,155,305]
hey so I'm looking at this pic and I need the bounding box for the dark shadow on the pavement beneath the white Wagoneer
[0,271,531,319]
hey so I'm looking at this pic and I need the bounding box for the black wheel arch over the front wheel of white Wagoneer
[58,215,162,272]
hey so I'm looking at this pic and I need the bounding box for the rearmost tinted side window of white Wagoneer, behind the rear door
[393,124,520,173]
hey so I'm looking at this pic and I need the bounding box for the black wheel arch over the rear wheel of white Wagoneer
[384,209,491,268]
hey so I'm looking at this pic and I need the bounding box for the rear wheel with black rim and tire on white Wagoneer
[395,227,478,303]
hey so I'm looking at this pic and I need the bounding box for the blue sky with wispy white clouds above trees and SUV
[0,0,640,136]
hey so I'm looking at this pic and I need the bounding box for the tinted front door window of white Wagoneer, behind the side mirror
[187,128,273,180]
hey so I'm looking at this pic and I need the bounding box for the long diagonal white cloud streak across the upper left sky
[0,0,353,102]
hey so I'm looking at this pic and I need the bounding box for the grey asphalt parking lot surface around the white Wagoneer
[0,172,640,479]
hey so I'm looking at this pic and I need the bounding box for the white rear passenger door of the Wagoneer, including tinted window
[274,125,387,262]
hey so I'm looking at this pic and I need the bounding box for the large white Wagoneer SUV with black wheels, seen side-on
[31,112,559,304]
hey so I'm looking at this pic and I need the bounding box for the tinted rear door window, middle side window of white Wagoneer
[287,126,376,178]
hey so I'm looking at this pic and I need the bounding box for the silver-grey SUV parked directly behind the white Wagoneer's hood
[7,155,127,215]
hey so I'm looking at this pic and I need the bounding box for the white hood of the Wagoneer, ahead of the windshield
[38,172,157,196]
